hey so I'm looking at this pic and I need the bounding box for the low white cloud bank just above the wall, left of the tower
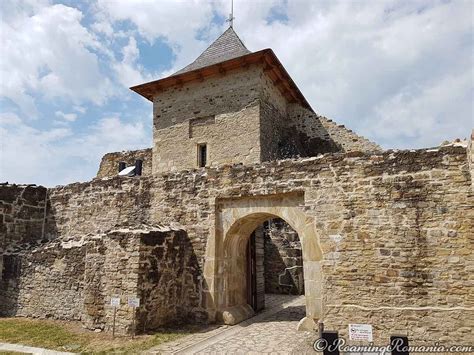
[0,113,151,186]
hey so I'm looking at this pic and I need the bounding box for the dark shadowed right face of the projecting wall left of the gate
[138,230,207,331]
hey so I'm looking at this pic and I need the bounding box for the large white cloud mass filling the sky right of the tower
[231,0,474,148]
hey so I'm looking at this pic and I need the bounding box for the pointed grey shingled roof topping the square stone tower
[173,27,252,75]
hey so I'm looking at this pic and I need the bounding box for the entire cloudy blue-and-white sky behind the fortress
[0,0,474,186]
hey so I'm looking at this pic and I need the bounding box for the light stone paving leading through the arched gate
[149,295,316,354]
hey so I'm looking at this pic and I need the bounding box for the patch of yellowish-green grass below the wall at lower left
[0,318,189,354]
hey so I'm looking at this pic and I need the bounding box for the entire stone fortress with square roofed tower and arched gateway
[0,27,474,344]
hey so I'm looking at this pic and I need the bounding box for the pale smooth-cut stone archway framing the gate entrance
[204,193,322,329]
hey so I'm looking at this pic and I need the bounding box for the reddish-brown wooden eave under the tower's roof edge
[130,48,314,112]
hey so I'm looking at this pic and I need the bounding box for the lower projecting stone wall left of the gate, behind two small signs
[0,227,201,334]
